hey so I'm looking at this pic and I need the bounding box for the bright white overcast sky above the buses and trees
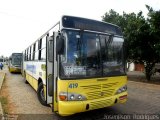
[0,0,160,57]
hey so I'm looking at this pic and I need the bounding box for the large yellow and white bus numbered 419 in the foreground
[23,16,127,116]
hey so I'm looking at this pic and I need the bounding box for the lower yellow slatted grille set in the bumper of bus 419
[90,99,113,109]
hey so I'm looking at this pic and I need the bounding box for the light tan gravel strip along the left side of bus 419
[6,66,52,114]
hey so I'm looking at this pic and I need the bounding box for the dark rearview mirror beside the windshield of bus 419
[56,35,64,55]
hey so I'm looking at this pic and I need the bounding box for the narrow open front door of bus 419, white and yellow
[46,33,58,112]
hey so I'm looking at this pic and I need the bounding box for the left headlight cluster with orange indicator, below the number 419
[59,92,86,101]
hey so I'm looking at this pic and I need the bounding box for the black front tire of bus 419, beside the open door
[37,82,48,106]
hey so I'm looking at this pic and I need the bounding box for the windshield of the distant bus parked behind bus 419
[12,54,22,65]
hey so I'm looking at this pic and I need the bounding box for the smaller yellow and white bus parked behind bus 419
[8,53,22,73]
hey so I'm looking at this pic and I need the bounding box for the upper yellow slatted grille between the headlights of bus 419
[81,82,118,100]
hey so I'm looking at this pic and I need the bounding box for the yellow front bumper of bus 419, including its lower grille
[58,92,128,116]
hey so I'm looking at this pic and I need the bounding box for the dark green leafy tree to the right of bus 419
[102,5,160,80]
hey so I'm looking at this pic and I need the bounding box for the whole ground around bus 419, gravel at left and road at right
[1,67,160,120]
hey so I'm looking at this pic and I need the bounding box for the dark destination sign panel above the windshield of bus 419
[62,15,122,36]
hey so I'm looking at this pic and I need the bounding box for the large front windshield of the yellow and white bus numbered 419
[60,30,125,79]
